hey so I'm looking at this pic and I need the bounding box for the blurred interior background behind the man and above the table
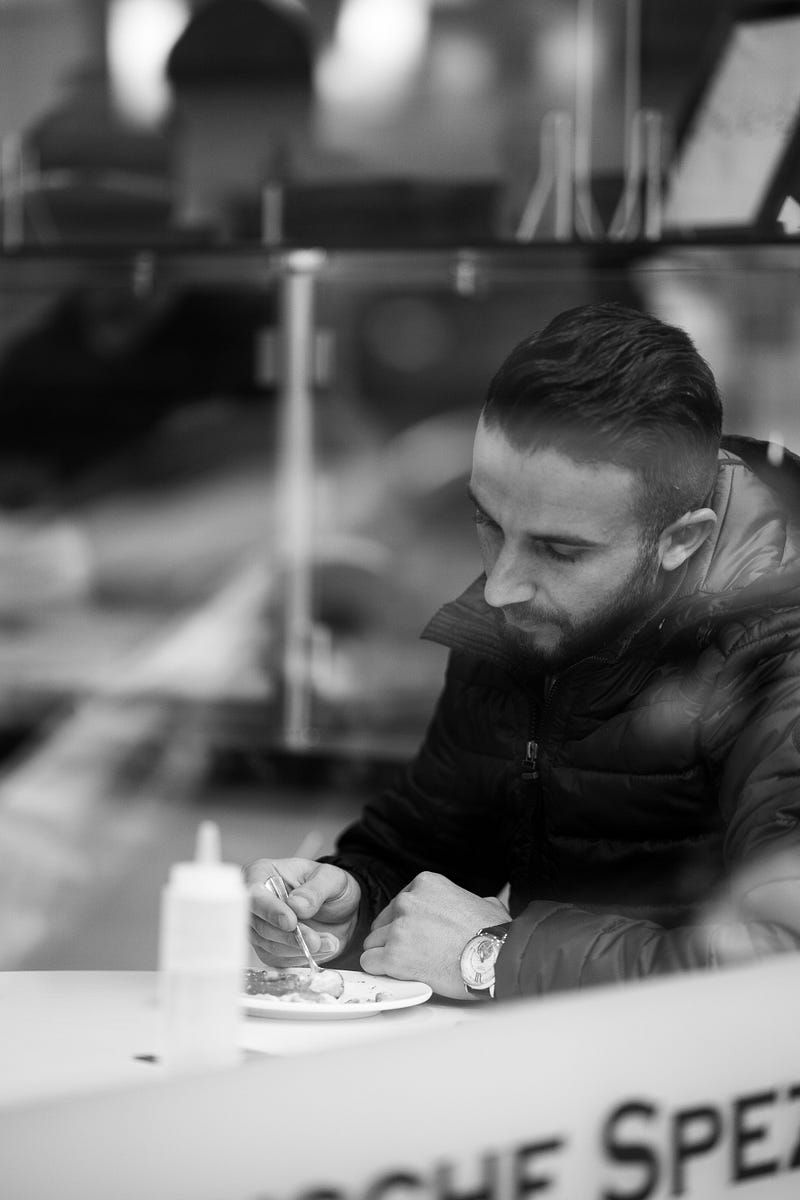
[0,0,800,968]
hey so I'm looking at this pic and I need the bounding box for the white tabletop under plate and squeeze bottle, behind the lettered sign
[0,971,483,1106]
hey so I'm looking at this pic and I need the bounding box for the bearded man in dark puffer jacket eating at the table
[248,305,800,997]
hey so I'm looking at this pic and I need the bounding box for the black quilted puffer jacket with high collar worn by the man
[332,439,800,996]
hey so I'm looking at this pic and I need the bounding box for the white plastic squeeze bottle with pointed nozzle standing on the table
[158,821,248,1072]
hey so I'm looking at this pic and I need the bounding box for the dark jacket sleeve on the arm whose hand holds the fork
[325,654,505,953]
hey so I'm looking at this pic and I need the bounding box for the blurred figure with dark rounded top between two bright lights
[167,0,339,241]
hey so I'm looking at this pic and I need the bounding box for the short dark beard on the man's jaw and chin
[494,547,662,674]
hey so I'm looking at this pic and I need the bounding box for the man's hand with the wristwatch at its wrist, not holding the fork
[361,871,510,1000]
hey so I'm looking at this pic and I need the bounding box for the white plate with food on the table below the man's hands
[241,971,433,1021]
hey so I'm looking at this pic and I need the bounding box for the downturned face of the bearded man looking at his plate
[470,421,661,672]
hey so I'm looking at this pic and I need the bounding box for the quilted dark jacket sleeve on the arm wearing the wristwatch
[497,619,800,997]
